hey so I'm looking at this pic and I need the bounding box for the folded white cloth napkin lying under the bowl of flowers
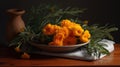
[30,39,115,60]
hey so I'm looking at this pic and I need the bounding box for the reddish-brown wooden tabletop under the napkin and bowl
[0,44,120,67]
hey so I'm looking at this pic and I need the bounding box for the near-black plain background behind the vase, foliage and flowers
[0,0,120,44]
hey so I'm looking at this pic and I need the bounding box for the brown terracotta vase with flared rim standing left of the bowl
[6,9,25,42]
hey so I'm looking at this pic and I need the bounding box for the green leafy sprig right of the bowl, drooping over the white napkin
[85,24,118,57]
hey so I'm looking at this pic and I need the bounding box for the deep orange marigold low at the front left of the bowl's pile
[49,33,65,46]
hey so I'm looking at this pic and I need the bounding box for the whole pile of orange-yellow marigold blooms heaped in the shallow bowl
[43,19,91,46]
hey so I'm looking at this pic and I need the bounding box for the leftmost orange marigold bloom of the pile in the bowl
[43,24,56,35]
